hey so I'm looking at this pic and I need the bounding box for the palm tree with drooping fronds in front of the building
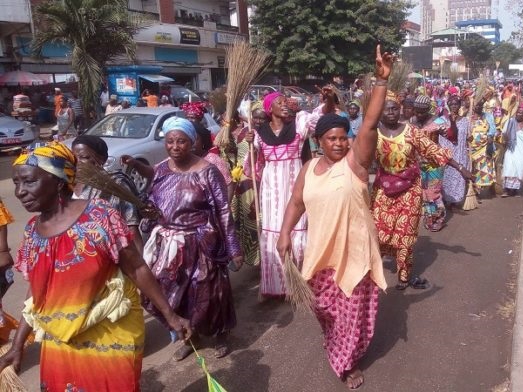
[32,0,144,115]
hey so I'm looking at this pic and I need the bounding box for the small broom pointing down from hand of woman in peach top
[283,254,316,313]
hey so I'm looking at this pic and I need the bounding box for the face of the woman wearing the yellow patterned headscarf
[13,165,61,212]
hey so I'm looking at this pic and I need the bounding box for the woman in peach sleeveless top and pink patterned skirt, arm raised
[277,46,393,389]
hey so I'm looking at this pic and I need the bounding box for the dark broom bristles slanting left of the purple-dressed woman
[76,163,145,208]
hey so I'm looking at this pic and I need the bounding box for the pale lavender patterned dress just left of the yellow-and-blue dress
[439,117,470,203]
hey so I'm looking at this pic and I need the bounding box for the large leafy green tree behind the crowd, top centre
[250,0,412,76]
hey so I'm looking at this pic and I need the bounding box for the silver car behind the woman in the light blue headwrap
[66,107,185,192]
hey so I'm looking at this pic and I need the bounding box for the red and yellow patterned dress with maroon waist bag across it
[372,124,451,282]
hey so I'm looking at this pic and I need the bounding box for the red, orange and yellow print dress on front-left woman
[16,199,145,392]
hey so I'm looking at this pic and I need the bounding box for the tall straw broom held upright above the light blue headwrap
[214,41,269,149]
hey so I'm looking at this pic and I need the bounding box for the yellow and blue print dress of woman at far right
[470,113,496,187]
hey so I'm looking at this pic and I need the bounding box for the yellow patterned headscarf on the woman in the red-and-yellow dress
[13,141,76,190]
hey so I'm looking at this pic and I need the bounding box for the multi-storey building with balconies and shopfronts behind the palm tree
[0,0,249,91]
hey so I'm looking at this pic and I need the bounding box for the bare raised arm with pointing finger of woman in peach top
[349,45,394,179]
